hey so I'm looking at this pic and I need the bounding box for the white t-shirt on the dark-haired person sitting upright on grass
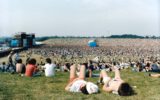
[43,63,56,77]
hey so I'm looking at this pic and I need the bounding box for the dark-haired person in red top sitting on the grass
[25,58,40,77]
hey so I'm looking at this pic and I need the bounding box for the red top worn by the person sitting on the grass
[25,64,36,77]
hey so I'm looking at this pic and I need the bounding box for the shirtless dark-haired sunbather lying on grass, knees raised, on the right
[98,67,133,96]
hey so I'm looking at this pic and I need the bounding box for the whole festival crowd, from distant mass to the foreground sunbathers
[0,40,160,96]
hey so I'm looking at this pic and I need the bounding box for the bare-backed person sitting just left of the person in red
[16,59,26,74]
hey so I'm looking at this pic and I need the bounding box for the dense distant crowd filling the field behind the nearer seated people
[19,39,160,66]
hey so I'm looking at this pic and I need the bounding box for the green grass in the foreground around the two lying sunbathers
[0,70,160,100]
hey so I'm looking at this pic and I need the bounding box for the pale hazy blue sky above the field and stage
[0,0,160,37]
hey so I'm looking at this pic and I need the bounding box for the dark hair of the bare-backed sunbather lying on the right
[118,83,133,96]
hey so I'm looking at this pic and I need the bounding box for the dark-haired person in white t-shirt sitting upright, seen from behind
[43,58,56,77]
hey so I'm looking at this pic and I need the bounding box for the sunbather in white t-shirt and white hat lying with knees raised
[65,64,99,94]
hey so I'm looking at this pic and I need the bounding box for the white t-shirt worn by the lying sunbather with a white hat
[69,80,87,92]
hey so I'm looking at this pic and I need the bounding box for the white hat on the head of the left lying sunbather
[86,82,98,94]
